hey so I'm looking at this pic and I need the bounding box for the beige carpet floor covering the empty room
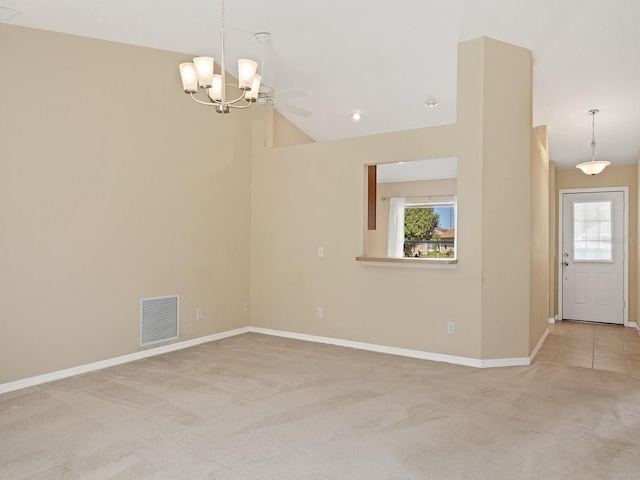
[0,334,640,480]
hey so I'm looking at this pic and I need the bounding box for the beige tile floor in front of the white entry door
[535,320,640,376]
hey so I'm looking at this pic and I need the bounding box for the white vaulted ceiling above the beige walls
[0,0,640,168]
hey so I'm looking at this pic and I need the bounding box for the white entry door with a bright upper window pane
[560,192,625,325]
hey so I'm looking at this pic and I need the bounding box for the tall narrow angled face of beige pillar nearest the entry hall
[481,40,532,358]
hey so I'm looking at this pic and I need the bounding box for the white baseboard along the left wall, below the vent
[0,327,250,394]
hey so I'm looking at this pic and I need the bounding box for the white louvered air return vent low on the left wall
[140,295,178,347]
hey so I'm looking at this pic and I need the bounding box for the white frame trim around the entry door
[556,187,629,327]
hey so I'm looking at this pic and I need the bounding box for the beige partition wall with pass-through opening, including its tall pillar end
[251,38,548,359]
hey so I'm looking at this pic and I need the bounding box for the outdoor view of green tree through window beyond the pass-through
[404,205,456,258]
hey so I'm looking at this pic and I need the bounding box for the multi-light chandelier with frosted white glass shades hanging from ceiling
[180,0,262,113]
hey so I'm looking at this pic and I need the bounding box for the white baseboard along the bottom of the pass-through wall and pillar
[249,327,530,368]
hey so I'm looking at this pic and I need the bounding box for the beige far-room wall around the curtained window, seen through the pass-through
[366,178,456,257]
